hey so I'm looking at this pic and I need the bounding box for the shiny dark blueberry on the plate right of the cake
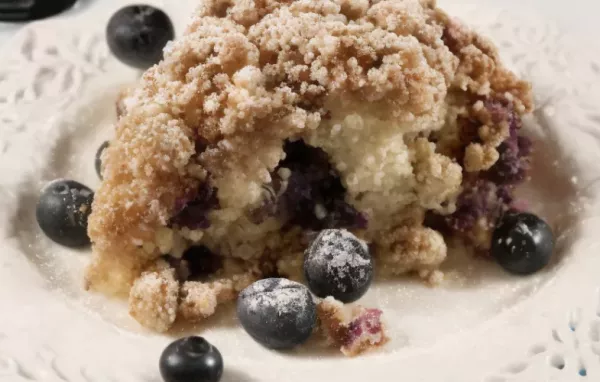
[491,212,554,275]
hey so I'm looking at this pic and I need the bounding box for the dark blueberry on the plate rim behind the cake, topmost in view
[106,5,175,70]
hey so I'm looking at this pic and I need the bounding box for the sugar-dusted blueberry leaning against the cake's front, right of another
[304,229,373,302]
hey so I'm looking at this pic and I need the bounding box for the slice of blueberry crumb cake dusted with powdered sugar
[86,0,532,331]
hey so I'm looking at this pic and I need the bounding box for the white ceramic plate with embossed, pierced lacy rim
[0,0,600,382]
